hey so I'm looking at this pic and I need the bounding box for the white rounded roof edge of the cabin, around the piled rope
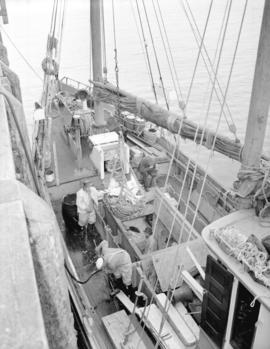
[202,209,270,310]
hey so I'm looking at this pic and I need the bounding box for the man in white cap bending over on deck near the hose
[96,240,134,296]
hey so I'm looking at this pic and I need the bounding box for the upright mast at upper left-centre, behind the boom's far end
[90,0,105,125]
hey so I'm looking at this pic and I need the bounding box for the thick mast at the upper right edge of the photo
[242,0,270,168]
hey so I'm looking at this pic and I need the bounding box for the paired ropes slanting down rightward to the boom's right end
[184,1,238,141]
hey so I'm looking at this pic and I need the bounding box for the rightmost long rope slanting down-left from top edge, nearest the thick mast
[186,0,248,242]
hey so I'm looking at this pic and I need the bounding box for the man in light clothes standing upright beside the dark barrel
[76,181,98,230]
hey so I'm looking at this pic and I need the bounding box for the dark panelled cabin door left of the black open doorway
[201,256,233,348]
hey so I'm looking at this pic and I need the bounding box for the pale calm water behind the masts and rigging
[2,0,270,185]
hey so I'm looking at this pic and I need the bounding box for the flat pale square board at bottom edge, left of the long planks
[102,310,154,349]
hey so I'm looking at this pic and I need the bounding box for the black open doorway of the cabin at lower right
[231,283,260,349]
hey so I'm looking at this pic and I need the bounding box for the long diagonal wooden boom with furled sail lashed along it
[93,81,242,161]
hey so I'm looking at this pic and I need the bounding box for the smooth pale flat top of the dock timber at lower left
[0,201,48,349]
